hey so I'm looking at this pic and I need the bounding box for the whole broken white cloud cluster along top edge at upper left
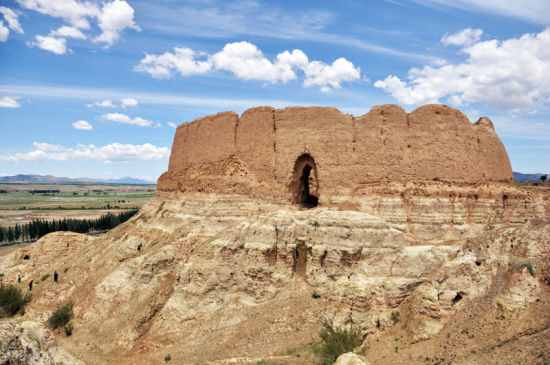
[17,0,140,54]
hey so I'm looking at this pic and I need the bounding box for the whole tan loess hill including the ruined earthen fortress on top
[0,105,550,364]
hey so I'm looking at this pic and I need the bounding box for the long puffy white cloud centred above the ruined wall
[134,42,361,91]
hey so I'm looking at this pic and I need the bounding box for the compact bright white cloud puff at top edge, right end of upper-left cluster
[94,0,141,46]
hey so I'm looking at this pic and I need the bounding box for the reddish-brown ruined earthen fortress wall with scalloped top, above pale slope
[158,105,513,202]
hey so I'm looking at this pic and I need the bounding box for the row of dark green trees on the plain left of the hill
[0,209,138,242]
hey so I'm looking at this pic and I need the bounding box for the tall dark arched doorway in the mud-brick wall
[290,154,319,208]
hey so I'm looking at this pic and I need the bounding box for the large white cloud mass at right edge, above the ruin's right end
[374,28,550,112]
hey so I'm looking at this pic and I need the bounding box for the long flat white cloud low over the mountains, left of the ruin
[0,142,170,163]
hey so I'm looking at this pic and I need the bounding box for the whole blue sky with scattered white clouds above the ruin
[0,0,550,181]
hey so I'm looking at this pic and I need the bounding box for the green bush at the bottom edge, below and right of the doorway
[313,319,361,365]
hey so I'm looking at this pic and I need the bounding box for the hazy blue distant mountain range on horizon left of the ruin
[0,174,156,185]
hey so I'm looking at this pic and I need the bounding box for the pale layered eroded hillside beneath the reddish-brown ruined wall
[1,182,550,364]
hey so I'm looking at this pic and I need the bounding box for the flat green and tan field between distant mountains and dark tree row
[0,184,155,226]
